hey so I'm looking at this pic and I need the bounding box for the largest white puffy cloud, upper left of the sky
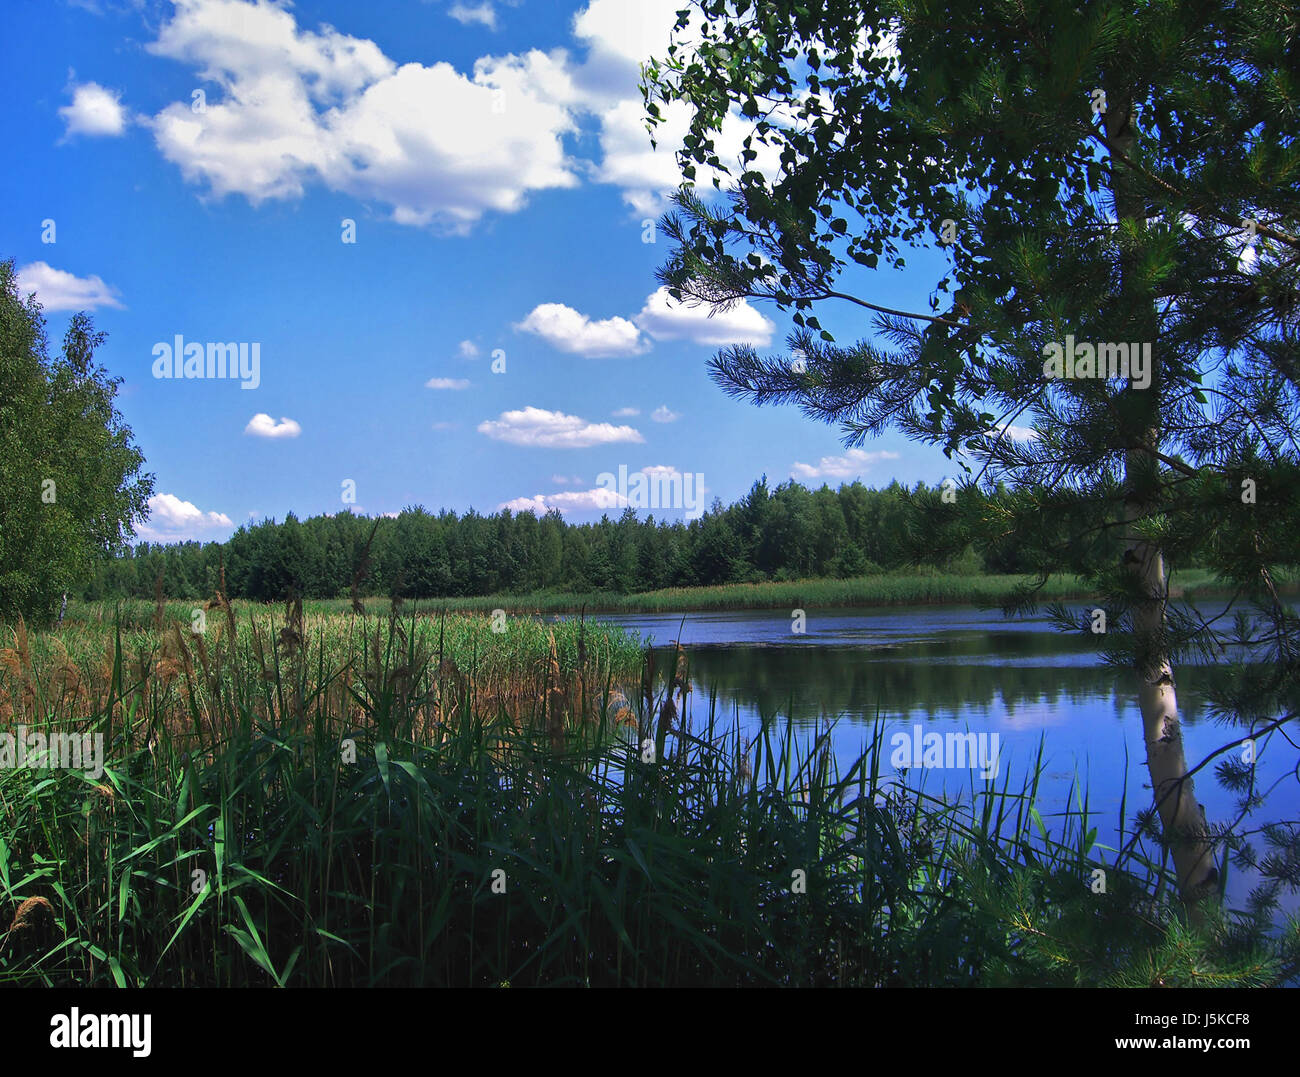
[141,0,577,232]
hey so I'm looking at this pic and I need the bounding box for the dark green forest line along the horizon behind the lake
[83,476,1066,601]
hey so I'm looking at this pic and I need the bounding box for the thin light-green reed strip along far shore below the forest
[65,568,1248,623]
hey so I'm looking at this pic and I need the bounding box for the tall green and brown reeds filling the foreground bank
[0,602,1295,986]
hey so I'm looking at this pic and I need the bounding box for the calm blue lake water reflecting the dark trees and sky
[587,606,1300,909]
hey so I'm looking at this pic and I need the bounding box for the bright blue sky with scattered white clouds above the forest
[0,0,953,541]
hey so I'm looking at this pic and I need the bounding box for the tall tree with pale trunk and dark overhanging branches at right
[644,0,1300,900]
